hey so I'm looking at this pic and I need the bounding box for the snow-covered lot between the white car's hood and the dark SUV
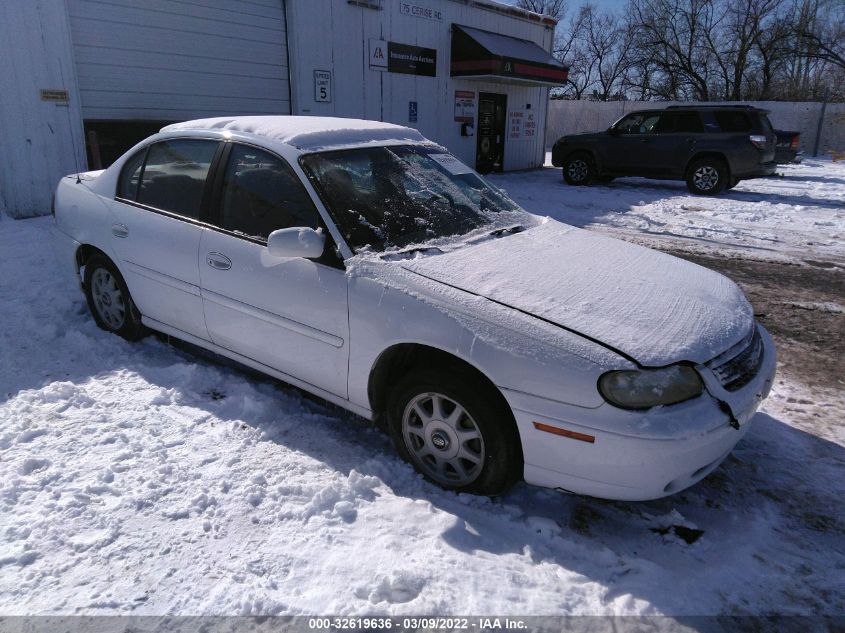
[491,154,845,267]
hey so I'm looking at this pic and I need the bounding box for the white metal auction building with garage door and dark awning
[0,0,566,217]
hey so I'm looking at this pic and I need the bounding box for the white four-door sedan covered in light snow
[54,116,775,500]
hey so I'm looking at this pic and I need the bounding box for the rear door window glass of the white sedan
[137,139,218,220]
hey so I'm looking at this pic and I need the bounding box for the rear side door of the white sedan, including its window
[111,139,220,339]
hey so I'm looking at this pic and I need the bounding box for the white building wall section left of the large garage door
[0,0,86,218]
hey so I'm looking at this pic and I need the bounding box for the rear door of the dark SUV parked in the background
[649,110,704,177]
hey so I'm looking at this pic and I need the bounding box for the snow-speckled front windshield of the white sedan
[301,146,526,253]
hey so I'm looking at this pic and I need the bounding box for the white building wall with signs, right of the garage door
[287,0,553,170]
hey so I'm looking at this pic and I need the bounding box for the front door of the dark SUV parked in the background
[602,112,660,176]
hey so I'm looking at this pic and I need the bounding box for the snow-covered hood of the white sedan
[401,220,754,367]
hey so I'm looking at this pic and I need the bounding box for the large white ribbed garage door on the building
[68,0,290,121]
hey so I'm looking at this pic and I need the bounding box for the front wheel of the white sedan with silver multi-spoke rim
[387,369,523,495]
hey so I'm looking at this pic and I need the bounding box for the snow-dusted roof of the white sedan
[161,116,427,150]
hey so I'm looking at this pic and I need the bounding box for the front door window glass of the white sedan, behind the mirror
[219,145,320,239]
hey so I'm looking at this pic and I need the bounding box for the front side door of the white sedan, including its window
[199,143,349,398]
